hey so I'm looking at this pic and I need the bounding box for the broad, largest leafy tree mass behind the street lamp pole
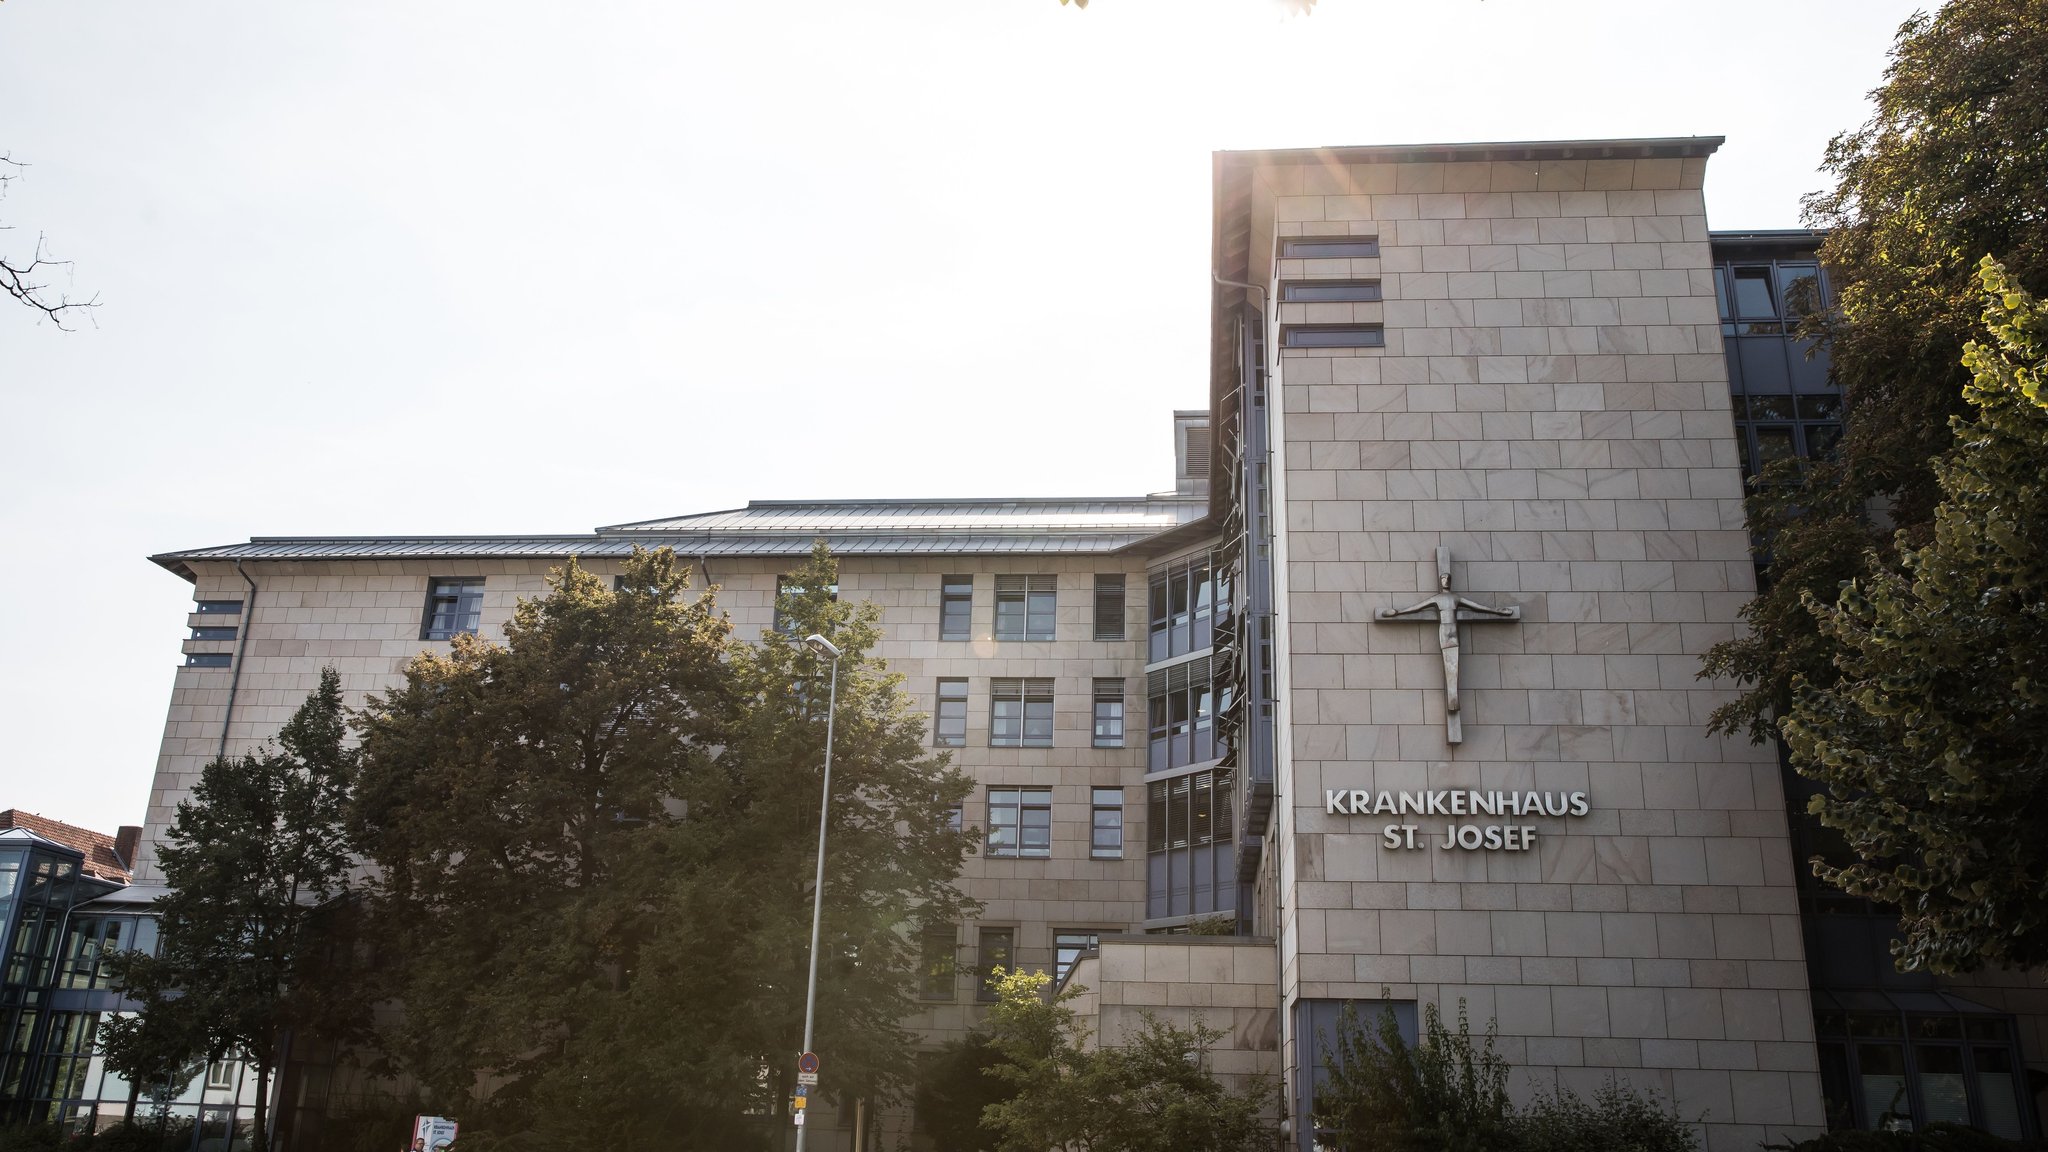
[358,549,969,1150]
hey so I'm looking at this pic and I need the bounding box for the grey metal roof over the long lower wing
[150,496,1206,580]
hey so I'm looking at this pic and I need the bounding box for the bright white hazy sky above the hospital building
[0,0,1917,832]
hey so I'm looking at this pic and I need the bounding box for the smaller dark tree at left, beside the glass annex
[102,668,362,1148]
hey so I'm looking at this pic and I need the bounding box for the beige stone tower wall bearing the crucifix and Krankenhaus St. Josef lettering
[1212,143,1823,1148]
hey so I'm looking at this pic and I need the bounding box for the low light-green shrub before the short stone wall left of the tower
[983,970,1274,1152]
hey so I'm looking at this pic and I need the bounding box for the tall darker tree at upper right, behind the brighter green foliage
[1704,0,2048,740]
